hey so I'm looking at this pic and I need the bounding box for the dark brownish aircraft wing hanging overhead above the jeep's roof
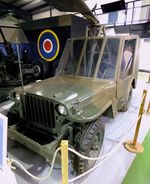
[45,0,99,25]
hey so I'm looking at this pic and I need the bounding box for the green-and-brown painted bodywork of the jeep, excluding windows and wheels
[8,36,139,164]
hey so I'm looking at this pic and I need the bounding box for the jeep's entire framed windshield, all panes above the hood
[57,37,120,80]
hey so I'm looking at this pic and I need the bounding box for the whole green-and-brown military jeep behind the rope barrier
[8,36,139,174]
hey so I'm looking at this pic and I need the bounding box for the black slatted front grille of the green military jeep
[21,93,55,130]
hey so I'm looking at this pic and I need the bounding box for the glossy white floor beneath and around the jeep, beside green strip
[0,72,150,184]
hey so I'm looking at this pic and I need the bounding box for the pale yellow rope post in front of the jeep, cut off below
[61,140,68,184]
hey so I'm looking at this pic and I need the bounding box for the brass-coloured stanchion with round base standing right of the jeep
[124,90,147,153]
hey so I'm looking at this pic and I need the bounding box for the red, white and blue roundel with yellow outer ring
[37,29,60,61]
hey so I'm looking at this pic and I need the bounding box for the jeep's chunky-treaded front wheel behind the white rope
[73,121,104,175]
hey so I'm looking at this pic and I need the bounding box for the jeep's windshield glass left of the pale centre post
[57,38,103,77]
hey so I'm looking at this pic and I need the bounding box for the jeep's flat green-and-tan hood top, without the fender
[18,76,114,106]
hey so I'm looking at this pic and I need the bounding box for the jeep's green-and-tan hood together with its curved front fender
[16,77,115,122]
